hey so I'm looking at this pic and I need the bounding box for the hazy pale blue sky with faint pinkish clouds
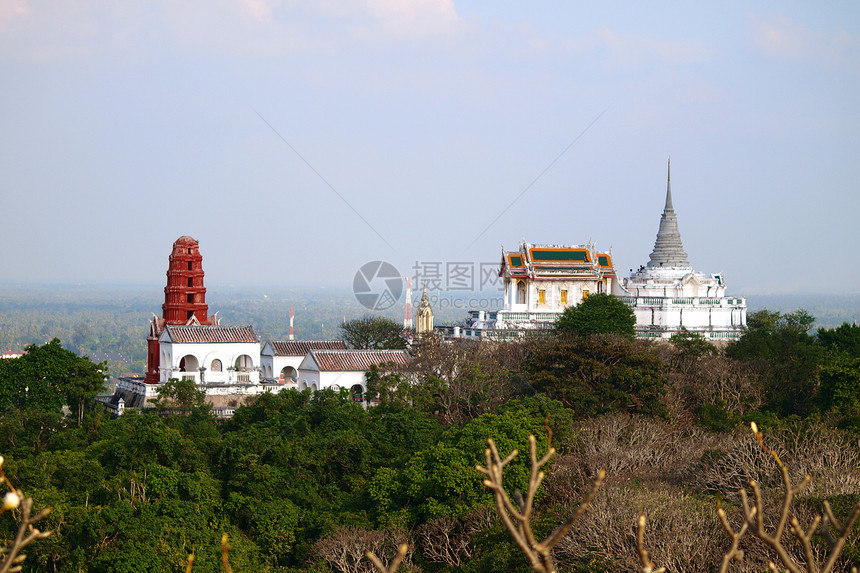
[0,0,860,294]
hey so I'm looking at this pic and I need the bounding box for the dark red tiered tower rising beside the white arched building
[145,235,216,384]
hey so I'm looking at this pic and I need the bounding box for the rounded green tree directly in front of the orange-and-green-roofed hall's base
[555,293,636,338]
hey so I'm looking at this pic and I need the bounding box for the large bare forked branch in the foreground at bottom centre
[475,435,606,573]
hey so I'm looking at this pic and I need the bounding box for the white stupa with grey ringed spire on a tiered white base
[611,161,747,341]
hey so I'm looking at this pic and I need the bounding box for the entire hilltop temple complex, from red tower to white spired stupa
[105,161,746,417]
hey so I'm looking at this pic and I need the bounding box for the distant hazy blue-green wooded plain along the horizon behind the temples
[0,284,860,375]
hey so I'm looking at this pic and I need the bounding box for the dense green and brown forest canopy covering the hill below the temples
[0,311,860,573]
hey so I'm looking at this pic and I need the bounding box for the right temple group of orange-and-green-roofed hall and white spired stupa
[437,161,747,342]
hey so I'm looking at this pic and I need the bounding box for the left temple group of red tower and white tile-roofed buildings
[104,236,406,417]
